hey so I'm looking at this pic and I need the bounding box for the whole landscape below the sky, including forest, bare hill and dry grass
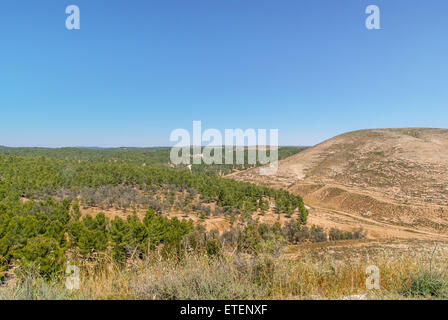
[0,129,448,299]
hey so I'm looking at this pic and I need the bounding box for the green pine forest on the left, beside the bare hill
[0,149,312,279]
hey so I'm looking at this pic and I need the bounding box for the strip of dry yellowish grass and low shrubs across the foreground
[0,248,448,300]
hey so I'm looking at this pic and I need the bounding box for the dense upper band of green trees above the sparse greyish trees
[0,155,308,220]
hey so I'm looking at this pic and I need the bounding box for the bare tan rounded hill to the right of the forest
[231,128,448,238]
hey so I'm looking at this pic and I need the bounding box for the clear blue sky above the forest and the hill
[0,0,448,147]
